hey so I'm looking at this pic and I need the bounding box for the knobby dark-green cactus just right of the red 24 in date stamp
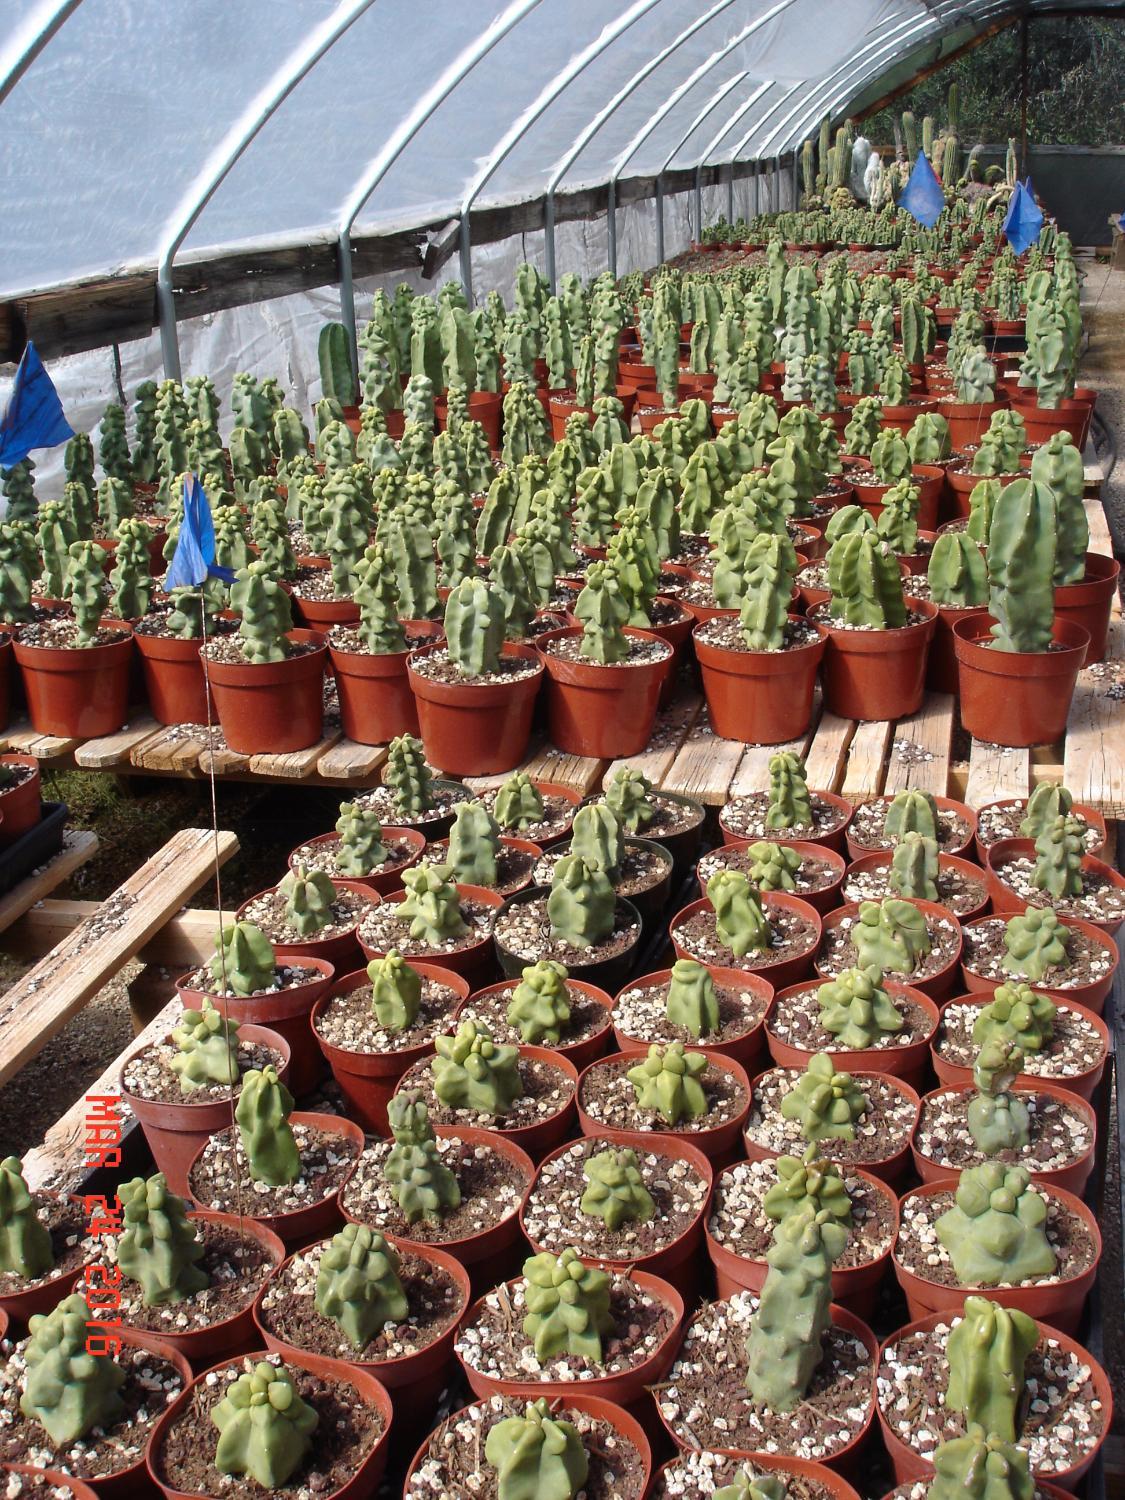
[117,1172,212,1307]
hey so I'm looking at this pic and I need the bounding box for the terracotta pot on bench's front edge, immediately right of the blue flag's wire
[207,630,329,755]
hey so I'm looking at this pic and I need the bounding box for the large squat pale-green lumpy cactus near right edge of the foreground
[935,1161,1058,1287]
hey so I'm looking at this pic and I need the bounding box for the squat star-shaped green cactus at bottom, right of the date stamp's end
[212,1359,320,1490]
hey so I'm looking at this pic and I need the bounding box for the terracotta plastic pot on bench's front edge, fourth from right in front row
[536,627,672,761]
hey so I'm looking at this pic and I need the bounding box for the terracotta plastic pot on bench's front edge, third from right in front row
[693,615,827,746]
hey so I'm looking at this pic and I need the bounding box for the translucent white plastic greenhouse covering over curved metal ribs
[0,0,1110,492]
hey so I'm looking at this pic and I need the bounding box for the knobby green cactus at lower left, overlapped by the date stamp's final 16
[20,1295,126,1449]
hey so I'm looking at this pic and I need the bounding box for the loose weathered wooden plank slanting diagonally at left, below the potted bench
[0,828,239,1085]
